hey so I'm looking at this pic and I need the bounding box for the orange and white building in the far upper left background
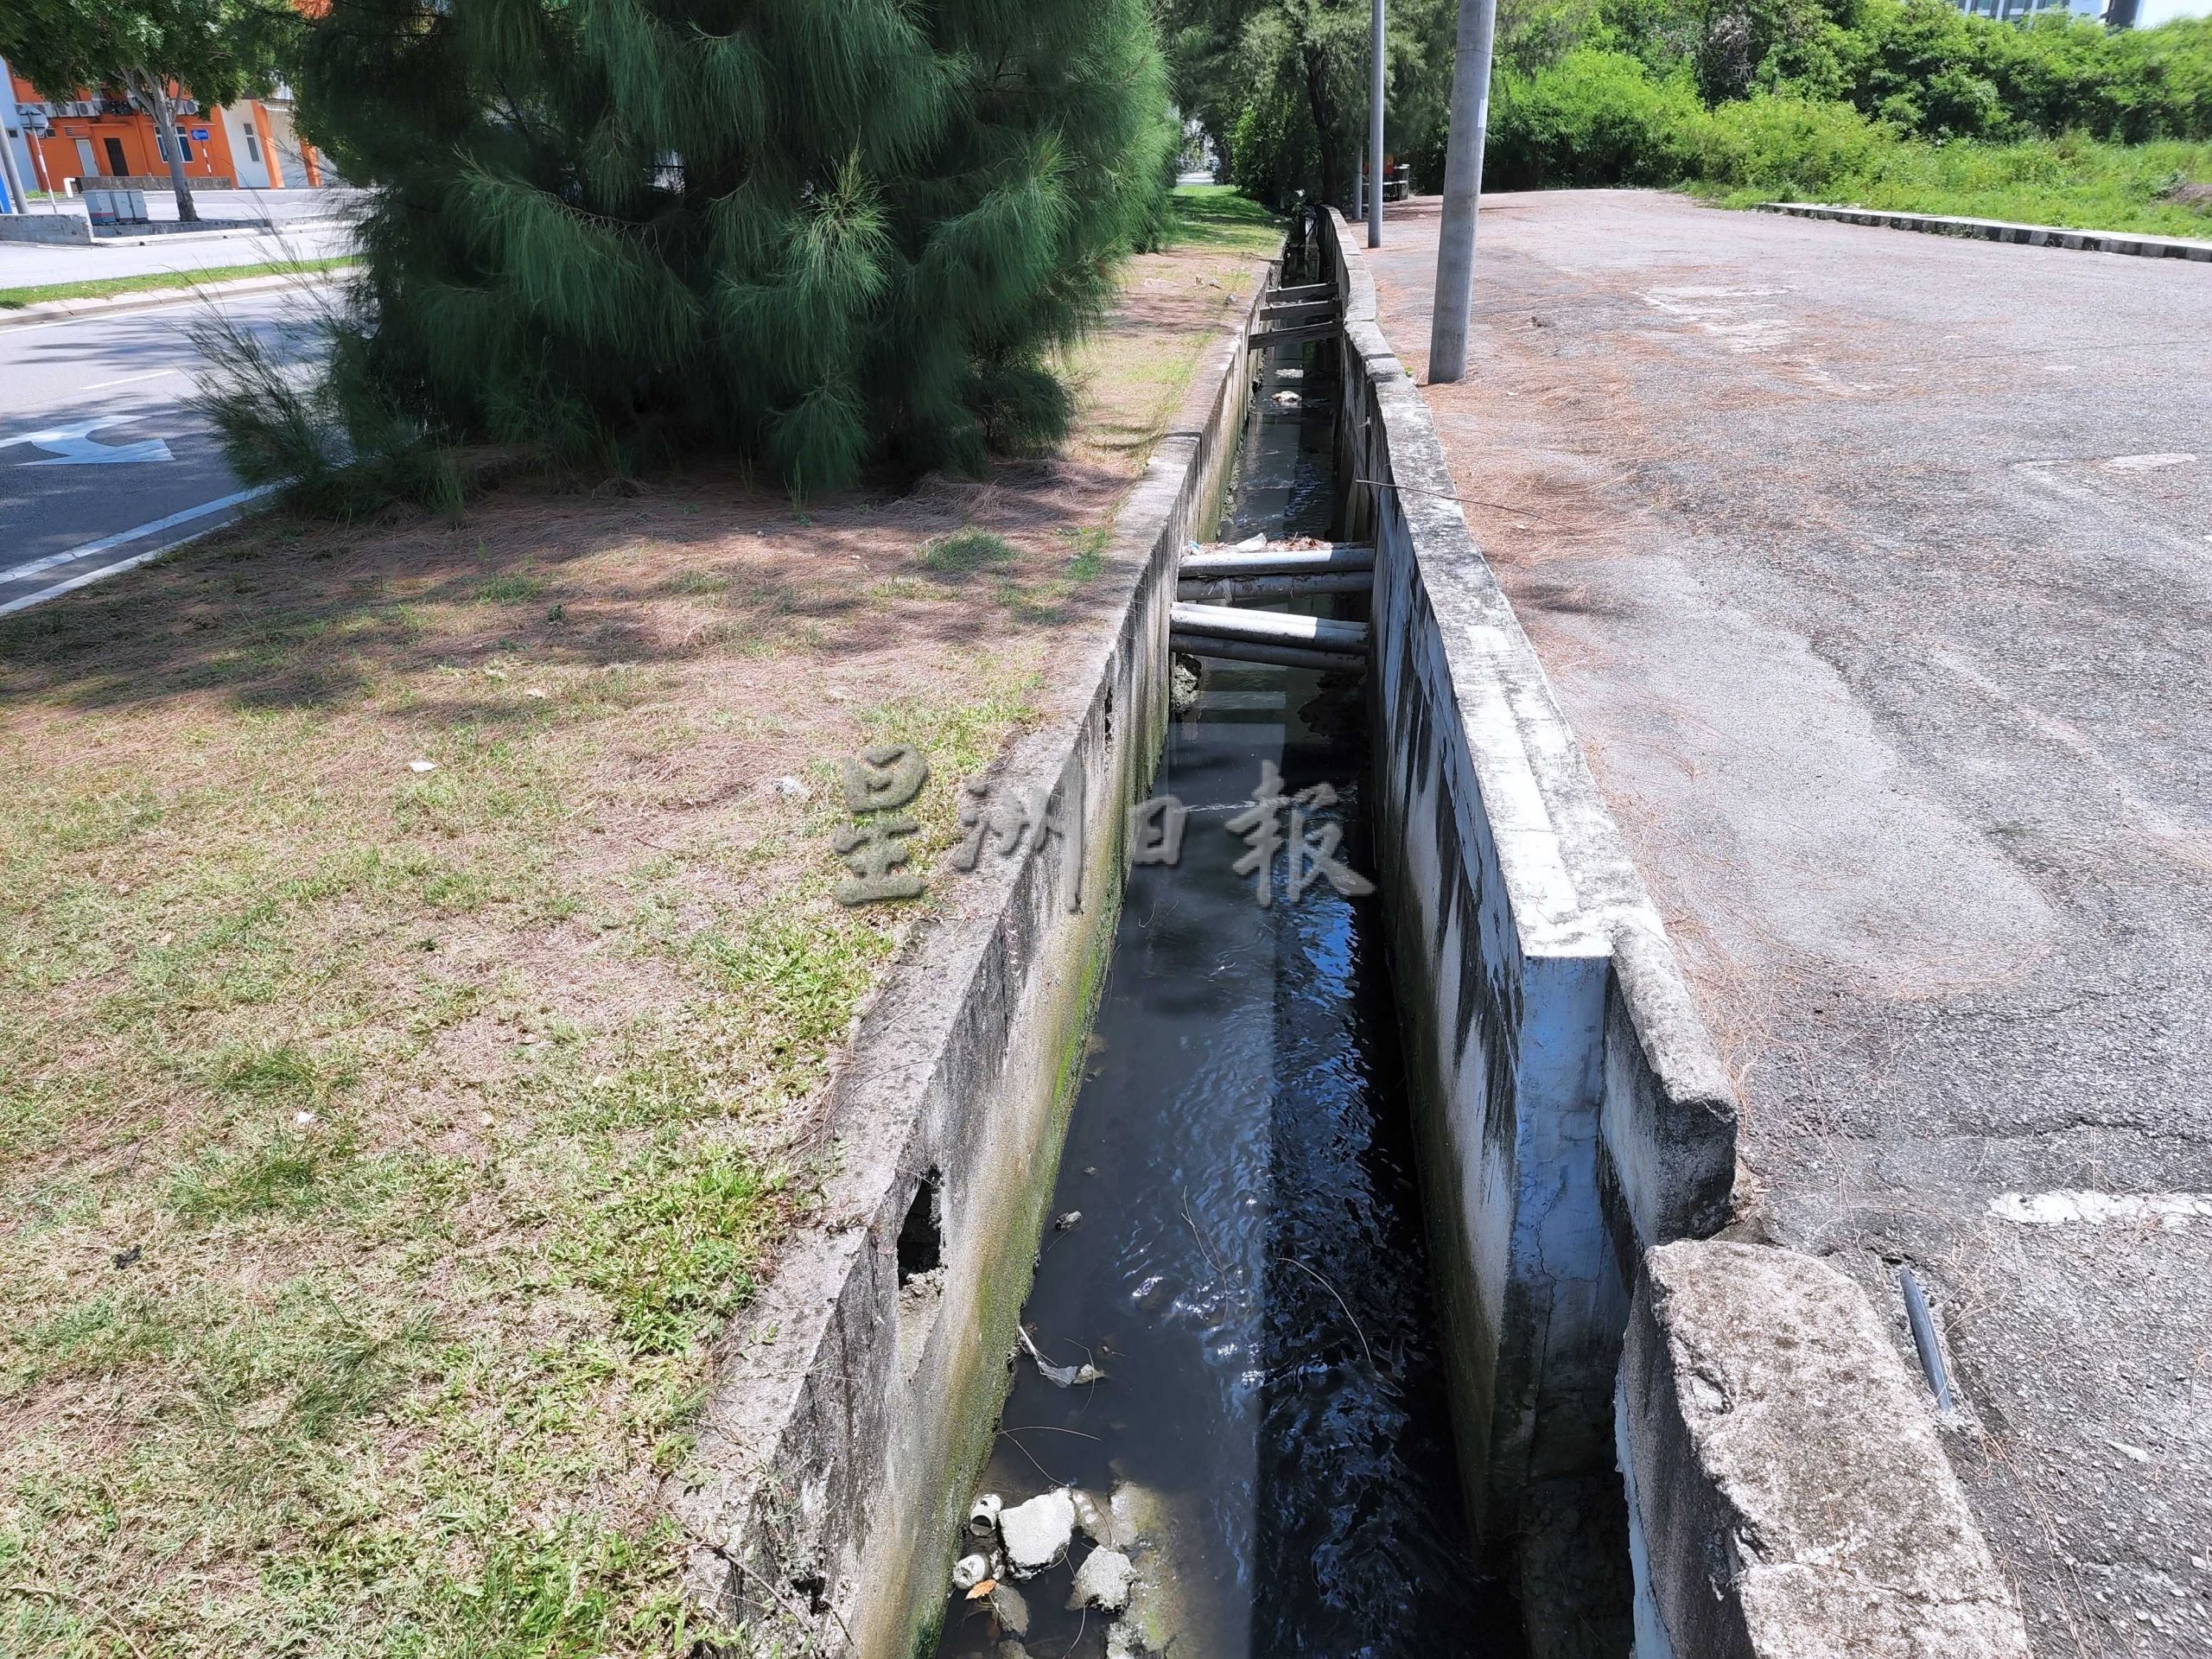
[11,75,323,190]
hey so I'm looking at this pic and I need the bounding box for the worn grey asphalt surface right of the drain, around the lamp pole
[1370,193,2212,1656]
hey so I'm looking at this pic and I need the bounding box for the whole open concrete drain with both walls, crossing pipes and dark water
[671,214,2026,1659]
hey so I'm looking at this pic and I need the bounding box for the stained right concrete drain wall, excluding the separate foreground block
[1319,213,1734,1652]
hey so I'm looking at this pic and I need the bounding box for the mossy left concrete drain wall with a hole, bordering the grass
[664,259,1259,1659]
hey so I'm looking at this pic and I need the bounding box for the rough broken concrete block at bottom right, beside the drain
[1617,1241,2029,1659]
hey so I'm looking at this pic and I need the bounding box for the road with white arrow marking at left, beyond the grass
[0,292,321,615]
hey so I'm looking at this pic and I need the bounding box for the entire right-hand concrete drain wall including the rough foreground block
[1316,213,2026,1659]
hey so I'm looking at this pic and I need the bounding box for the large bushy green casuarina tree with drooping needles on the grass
[233,0,1177,491]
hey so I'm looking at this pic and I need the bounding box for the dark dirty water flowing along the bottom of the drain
[938,327,1513,1659]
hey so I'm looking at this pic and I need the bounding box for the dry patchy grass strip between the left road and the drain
[0,194,1265,1656]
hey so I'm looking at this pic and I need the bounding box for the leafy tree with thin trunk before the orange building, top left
[0,0,299,219]
